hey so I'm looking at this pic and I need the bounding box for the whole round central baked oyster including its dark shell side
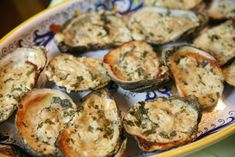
[104,41,169,92]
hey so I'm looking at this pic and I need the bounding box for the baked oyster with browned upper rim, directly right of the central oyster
[167,46,224,111]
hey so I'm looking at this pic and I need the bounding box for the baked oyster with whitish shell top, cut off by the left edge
[0,48,46,122]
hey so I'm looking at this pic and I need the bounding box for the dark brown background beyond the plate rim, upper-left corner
[0,0,50,38]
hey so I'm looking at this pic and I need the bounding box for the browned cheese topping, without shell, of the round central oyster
[105,42,160,81]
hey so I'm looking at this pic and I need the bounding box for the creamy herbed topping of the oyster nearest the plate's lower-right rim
[124,98,198,143]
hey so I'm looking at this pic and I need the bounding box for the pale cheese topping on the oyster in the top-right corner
[208,0,235,19]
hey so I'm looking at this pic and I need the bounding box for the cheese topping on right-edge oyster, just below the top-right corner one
[194,21,235,65]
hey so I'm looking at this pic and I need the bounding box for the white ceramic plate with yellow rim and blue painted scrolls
[0,0,235,157]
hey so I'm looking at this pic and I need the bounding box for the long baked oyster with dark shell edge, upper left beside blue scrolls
[55,12,132,54]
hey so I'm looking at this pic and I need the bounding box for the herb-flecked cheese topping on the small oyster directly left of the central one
[46,54,110,92]
